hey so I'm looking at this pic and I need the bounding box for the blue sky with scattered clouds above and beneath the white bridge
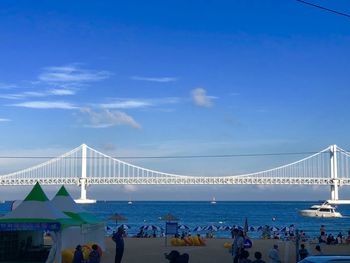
[0,0,350,200]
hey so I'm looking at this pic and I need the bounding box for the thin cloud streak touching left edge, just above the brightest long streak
[0,88,76,100]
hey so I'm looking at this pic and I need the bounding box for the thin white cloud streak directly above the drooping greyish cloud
[98,97,180,109]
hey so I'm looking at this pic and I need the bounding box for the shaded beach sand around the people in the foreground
[102,238,350,263]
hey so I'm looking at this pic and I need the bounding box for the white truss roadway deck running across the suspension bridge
[0,176,350,186]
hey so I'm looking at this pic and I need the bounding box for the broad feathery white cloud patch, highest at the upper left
[38,64,111,83]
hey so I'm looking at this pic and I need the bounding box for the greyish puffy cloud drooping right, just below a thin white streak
[80,108,141,129]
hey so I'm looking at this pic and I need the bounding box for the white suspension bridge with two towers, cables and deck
[0,144,350,203]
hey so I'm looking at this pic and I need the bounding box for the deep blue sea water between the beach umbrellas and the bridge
[0,201,350,238]
